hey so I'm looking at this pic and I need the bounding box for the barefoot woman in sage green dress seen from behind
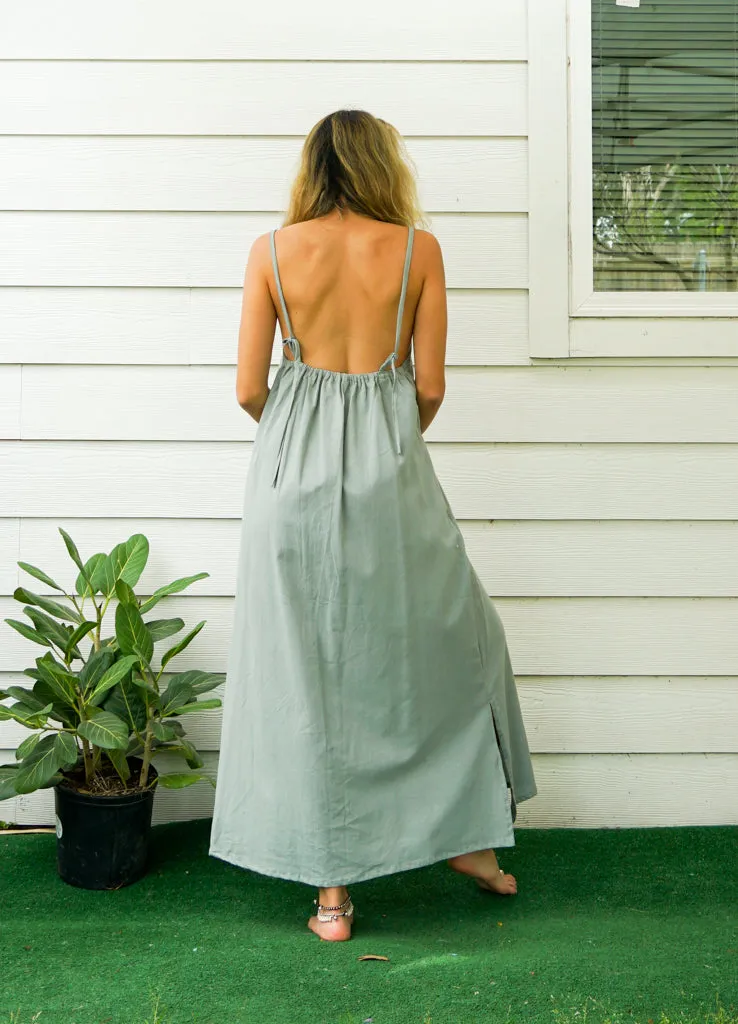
[209,111,536,940]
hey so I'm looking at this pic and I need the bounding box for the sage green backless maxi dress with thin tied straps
[209,228,537,887]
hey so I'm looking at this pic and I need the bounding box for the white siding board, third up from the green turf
[0,593,738,676]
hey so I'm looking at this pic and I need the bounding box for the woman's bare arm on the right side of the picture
[413,229,447,432]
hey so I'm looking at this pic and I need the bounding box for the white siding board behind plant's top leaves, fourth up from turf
[0,515,738,597]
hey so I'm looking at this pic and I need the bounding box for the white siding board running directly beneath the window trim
[18,366,738,442]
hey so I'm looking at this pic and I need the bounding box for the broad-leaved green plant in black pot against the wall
[0,527,225,889]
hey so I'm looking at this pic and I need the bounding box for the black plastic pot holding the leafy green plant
[53,758,158,889]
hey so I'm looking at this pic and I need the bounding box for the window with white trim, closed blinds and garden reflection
[529,0,738,356]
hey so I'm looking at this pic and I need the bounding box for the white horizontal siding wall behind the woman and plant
[0,0,738,826]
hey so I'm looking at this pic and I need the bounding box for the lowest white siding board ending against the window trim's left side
[0,288,529,366]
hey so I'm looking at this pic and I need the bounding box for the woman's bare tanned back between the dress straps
[269,214,423,374]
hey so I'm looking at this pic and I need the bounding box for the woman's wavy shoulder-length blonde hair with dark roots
[283,111,427,226]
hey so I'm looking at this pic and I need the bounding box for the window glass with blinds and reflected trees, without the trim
[592,0,738,292]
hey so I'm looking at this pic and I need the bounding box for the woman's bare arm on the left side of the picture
[235,232,276,423]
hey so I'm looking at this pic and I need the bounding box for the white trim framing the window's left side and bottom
[528,0,738,358]
